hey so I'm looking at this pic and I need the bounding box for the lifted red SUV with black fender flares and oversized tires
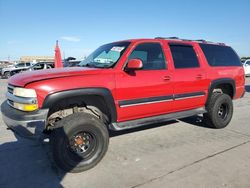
[1,37,245,172]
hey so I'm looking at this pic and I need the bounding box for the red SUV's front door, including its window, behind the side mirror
[116,42,173,122]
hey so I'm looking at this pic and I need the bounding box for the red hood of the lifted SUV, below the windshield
[9,67,101,87]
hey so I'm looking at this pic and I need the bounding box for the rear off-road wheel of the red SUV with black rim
[203,93,233,129]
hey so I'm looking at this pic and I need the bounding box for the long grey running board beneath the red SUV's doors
[109,108,207,131]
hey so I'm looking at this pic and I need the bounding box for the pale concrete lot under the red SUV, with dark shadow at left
[0,78,250,188]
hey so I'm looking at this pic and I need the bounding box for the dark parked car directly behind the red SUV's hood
[10,62,54,76]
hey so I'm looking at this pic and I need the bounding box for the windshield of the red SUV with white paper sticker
[79,42,130,68]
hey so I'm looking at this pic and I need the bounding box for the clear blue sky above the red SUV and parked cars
[0,0,250,60]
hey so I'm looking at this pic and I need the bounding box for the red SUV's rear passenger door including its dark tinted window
[169,43,208,111]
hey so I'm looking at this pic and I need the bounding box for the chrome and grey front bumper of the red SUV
[1,101,49,138]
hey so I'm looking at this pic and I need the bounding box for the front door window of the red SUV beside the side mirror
[129,43,166,70]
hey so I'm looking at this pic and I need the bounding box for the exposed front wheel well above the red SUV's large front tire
[48,95,111,129]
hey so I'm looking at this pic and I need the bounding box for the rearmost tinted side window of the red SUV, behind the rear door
[200,44,241,67]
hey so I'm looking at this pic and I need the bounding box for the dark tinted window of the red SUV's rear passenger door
[170,45,199,69]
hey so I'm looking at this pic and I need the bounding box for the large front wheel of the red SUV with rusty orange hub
[51,113,109,173]
